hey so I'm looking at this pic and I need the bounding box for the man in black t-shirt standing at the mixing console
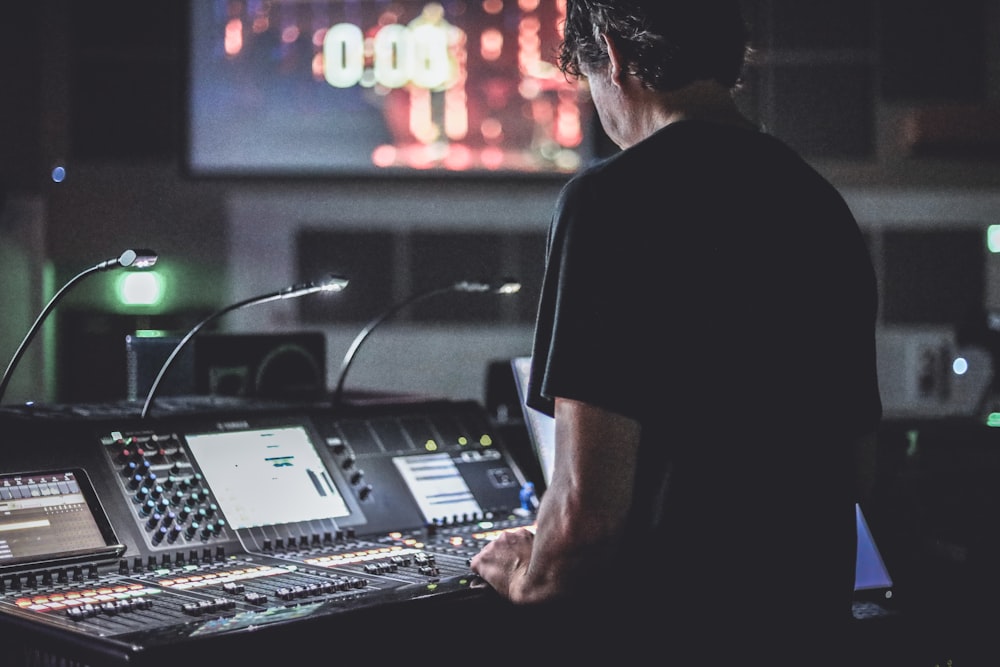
[471,0,881,665]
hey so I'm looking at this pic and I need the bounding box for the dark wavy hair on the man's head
[558,0,749,91]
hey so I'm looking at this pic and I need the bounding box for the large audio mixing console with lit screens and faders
[0,399,533,667]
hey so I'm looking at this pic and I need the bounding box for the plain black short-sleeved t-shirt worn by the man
[531,121,881,656]
